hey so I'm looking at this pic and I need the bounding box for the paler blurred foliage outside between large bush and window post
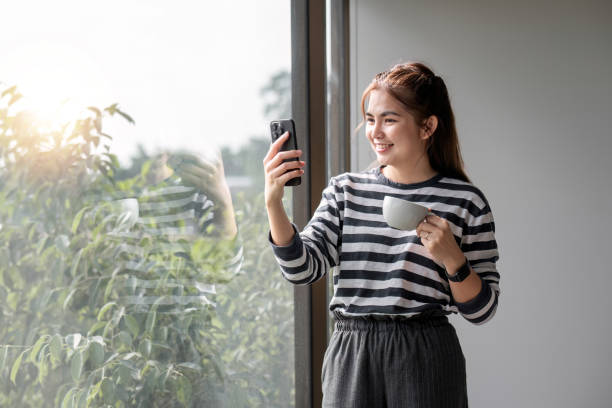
[215,193,295,408]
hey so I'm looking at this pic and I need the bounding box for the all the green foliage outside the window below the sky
[0,83,293,407]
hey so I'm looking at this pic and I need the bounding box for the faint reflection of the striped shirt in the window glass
[109,176,242,313]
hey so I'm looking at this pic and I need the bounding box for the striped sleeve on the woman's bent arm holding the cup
[456,204,500,325]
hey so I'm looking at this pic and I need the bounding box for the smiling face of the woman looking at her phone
[365,89,428,169]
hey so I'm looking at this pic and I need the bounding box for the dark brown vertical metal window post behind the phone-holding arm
[291,0,327,408]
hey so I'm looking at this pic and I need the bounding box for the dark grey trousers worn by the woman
[321,315,468,408]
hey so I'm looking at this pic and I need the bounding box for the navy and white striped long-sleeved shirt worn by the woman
[269,167,500,324]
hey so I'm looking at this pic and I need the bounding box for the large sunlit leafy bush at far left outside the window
[0,88,232,407]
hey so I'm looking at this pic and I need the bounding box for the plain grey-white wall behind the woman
[351,0,612,408]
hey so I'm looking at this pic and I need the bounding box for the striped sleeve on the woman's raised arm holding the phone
[268,179,343,285]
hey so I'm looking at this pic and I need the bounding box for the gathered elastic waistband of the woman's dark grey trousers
[334,313,450,331]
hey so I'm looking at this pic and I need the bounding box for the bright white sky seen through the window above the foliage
[0,0,291,163]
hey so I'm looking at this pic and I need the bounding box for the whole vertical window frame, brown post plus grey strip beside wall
[291,0,350,408]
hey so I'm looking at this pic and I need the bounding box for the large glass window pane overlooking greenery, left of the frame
[0,0,295,408]
